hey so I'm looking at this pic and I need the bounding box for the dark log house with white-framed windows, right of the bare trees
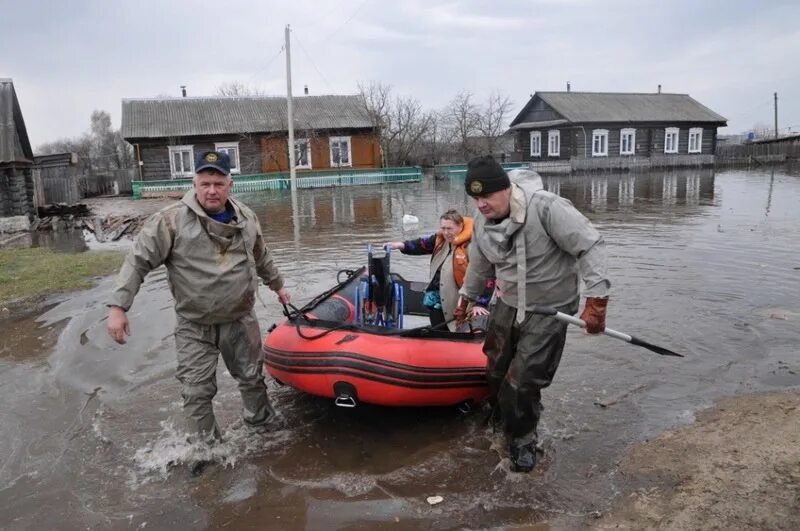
[510,91,726,170]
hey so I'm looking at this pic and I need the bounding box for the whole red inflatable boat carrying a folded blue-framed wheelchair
[264,253,488,407]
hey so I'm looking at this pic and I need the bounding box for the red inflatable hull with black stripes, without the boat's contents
[264,321,488,406]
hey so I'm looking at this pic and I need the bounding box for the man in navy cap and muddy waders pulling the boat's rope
[108,151,289,454]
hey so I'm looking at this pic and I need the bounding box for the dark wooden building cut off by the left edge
[0,79,36,232]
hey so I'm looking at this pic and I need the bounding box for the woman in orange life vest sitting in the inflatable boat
[385,210,494,331]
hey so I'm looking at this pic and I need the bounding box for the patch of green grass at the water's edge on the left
[0,247,125,305]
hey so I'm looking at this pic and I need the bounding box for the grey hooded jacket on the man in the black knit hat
[460,170,611,322]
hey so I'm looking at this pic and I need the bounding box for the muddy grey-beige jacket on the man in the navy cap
[109,190,283,324]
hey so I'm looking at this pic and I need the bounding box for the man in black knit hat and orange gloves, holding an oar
[456,157,610,472]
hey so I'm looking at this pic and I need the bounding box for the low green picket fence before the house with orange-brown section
[131,166,422,199]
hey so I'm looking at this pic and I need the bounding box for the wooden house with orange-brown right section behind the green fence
[121,95,381,181]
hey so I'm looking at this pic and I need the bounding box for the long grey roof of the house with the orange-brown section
[121,95,372,139]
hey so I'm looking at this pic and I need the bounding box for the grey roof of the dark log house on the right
[512,92,727,125]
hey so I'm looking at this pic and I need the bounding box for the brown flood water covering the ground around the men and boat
[0,165,800,529]
